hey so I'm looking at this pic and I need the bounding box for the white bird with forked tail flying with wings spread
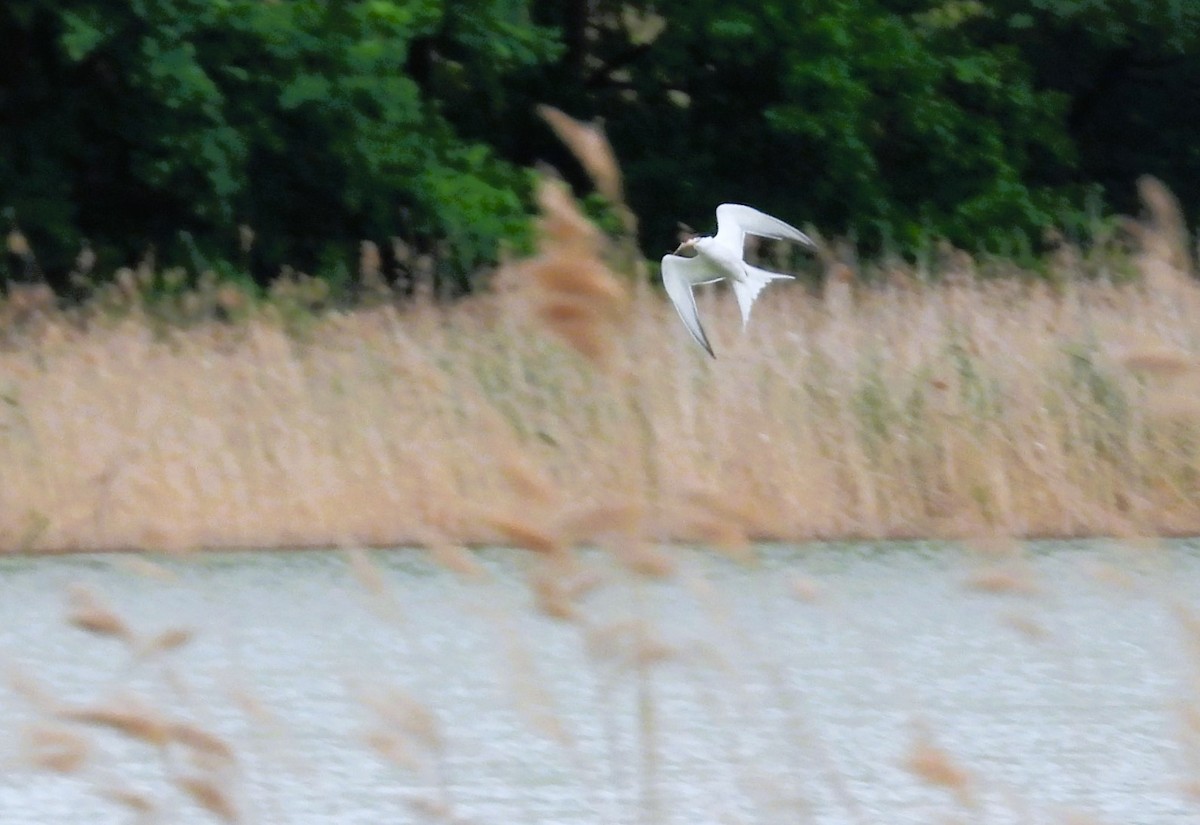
[662,204,816,359]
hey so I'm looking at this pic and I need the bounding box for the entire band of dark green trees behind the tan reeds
[0,0,1200,286]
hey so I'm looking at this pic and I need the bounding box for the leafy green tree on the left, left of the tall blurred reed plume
[0,0,557,281]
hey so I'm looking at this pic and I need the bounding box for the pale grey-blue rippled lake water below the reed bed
[0,541,1200,825]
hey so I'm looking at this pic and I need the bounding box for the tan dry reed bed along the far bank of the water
[0,117,1200,552]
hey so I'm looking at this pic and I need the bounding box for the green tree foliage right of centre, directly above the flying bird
[525,0,1073,246]
